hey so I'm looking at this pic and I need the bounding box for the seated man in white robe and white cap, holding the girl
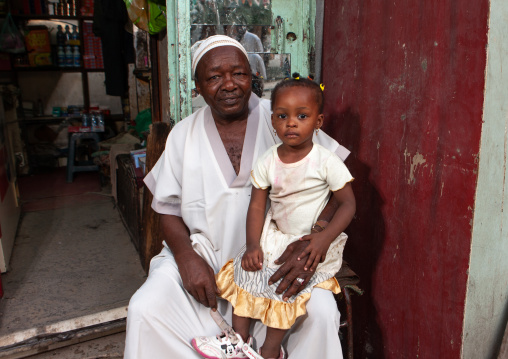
[125,36,349,359]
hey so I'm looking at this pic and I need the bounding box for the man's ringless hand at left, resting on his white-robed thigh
[176,250,220,309]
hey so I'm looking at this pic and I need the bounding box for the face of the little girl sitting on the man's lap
[272,86,324,149]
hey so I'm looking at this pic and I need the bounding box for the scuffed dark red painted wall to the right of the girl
[323,0,488,359]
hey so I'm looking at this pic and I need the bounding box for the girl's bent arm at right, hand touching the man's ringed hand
[298,183,356,271]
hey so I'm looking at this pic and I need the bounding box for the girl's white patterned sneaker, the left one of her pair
[191,331,254,359]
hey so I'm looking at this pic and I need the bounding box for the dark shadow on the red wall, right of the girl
[323,109,385,358]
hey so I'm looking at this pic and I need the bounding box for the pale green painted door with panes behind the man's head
[166,0,316,122]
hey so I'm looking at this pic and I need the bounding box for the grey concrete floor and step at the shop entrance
[0,171,145,358]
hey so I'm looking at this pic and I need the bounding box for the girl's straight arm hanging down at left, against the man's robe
[242,186,268,271]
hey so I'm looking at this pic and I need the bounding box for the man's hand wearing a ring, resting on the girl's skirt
[269,241,314,301]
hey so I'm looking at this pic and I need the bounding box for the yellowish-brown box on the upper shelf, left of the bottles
[25,26,53,67]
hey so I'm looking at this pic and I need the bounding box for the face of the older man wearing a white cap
[196,46,252,121]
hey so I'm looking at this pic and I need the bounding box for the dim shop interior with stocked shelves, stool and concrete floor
[0,0,167,357]
